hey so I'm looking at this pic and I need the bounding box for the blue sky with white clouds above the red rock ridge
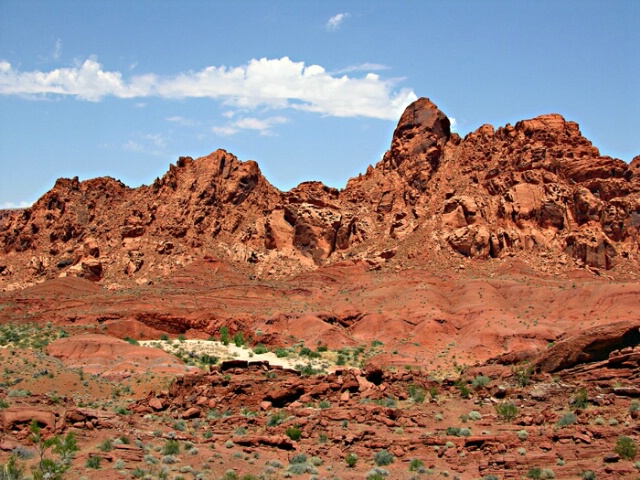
[0,0,640,208]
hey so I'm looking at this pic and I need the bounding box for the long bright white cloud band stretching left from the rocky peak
[0,57,417,120]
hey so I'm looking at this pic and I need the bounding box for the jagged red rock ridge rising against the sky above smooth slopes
[0,98,640,287]
